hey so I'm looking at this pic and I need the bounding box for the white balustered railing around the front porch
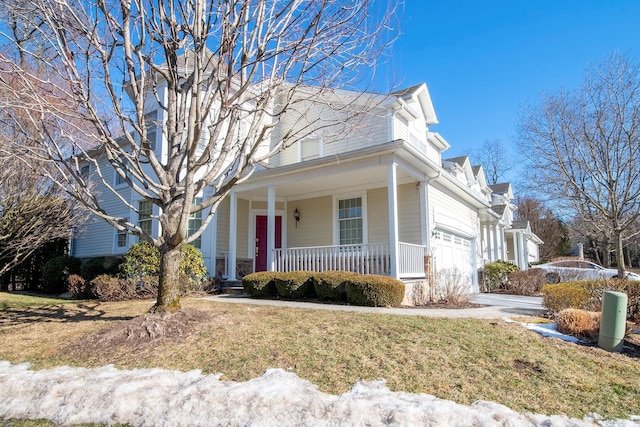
[274,243,424,277]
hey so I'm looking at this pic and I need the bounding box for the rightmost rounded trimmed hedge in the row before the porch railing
[346,274,404,307]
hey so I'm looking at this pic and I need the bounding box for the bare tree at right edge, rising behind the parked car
[519,54,640,276]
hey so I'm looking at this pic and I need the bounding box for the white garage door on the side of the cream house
[432,230,475,291]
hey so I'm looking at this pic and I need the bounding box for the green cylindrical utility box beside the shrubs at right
[598,291,627,353]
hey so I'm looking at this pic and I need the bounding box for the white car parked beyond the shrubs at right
[531,260,640,283]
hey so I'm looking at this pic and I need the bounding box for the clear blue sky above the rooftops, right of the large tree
[386,0,640,162]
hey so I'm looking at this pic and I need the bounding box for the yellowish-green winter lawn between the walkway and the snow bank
[0,293,640,418]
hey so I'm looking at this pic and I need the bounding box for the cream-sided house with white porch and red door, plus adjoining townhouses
[73,80,541,292]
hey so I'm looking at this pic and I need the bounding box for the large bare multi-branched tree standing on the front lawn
[4,0,393,312]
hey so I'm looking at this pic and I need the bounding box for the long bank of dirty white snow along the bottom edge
[0,362,640,427]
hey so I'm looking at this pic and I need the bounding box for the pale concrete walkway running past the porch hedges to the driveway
[204,294,546,319]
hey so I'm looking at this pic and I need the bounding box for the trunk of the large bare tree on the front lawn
[151,248,180,314]
